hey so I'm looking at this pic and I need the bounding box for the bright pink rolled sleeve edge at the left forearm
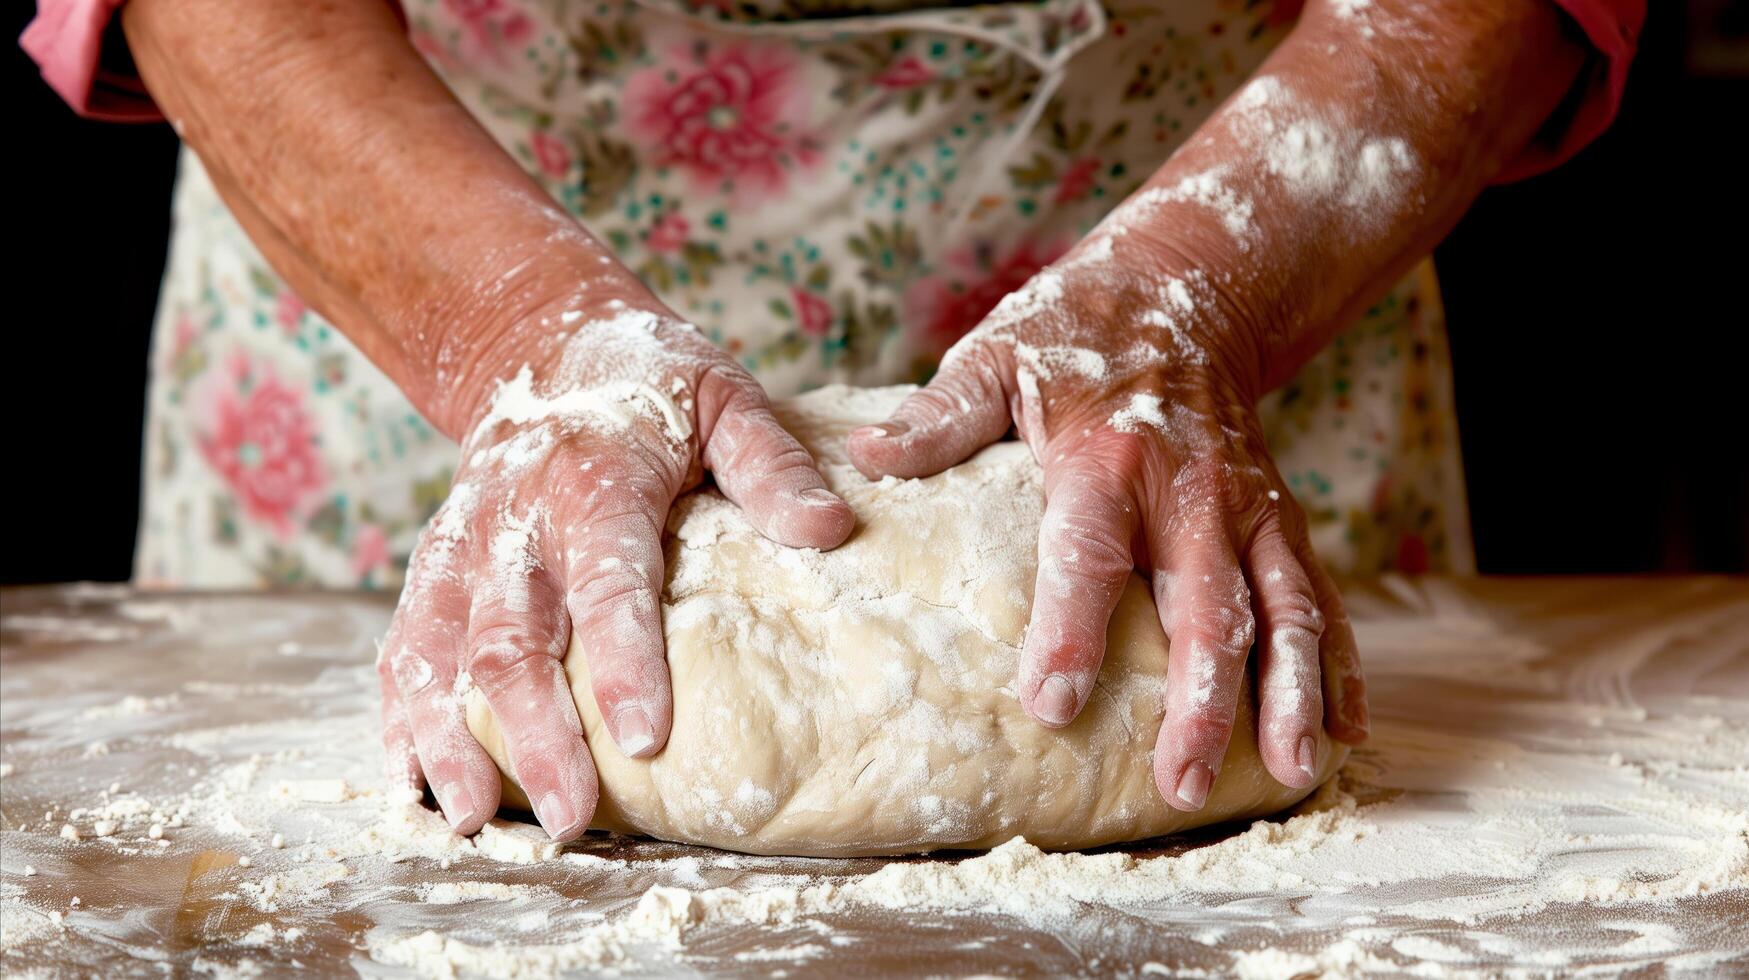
[17,0,159,123]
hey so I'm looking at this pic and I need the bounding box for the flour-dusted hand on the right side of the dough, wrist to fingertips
[850,231,1368,810]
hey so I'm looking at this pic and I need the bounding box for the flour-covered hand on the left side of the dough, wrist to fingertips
[378,301,855,840]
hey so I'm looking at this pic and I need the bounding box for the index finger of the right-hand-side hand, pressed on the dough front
[1020,455,1137,728]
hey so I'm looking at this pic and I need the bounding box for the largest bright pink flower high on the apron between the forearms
[626,44,819,193]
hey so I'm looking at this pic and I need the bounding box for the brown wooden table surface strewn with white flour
[0,578,1749,977]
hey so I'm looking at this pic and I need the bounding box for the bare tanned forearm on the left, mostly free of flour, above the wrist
[122,0,645,436]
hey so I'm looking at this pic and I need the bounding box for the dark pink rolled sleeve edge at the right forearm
[1495,0,1646,184]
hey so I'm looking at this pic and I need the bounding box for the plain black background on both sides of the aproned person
[0,0,1749,583]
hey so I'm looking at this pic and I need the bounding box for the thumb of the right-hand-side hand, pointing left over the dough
[848,347,1009,480]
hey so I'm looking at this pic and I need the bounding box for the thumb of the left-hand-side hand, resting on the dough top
[699,375,857,546]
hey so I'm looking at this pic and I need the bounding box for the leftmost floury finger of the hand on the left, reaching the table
[383,530,498,835]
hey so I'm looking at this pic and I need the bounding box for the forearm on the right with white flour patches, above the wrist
[1114,0,1585,394]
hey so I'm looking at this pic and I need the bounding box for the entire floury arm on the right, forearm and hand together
[850,0,1583,810]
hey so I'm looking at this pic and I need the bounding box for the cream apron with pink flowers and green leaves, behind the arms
[136,0,1473,588]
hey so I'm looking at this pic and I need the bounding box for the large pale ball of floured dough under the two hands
[467,387,1347,856]
